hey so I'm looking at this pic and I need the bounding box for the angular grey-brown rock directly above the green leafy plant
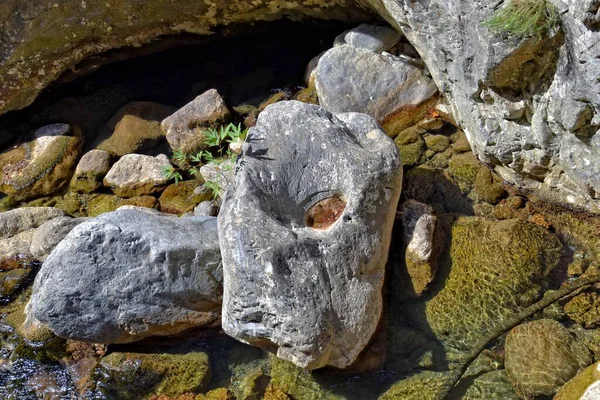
[162,89,231,153]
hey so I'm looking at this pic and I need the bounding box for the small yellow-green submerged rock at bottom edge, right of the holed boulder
[379,371,450,400]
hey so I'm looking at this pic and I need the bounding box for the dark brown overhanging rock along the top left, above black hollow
[0,0,372,114]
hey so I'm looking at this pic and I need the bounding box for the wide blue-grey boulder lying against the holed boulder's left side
[28,209,222,343]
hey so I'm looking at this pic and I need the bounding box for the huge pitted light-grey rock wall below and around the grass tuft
[365,0,600,212]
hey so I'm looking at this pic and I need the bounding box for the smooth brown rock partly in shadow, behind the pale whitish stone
[95,101,175,157]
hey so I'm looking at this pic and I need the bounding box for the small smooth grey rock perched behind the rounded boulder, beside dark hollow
[334,24,402,53]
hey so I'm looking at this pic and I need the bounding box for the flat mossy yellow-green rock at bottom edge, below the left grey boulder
[96,353,211,399]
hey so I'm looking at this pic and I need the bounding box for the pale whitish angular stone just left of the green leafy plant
[104,154,171,197]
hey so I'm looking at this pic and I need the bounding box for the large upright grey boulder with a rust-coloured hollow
[218,101,402,369]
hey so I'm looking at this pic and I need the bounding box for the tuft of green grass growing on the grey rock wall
[485,0,559,39]
